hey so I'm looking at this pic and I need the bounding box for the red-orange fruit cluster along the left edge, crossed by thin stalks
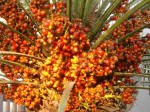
[0,0,43,80]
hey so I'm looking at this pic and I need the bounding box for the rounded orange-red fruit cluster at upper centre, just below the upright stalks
[39,16,90,57]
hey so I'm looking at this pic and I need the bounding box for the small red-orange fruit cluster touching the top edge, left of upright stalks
[30,0,66,23]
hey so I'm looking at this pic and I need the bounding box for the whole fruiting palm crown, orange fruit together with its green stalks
[0,0,150,112]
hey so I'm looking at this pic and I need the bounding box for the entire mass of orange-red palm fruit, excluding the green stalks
[0,0,150,112]
